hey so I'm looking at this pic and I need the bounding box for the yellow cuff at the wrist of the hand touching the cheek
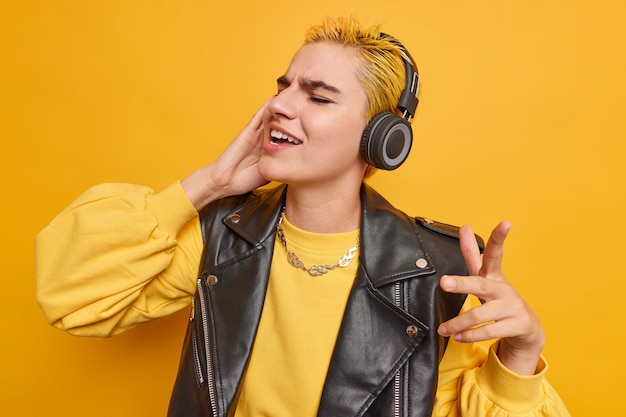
[146,181,198,237]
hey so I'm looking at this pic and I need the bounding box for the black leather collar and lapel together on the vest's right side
[318,186,435,417]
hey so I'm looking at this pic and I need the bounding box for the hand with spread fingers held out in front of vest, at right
[438,222,545,375]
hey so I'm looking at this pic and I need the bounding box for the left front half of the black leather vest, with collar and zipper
[191,187,284,416]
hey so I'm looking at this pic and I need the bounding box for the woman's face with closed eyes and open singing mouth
[259,43,367,186]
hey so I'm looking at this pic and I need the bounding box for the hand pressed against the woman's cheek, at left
[181,102,268,211]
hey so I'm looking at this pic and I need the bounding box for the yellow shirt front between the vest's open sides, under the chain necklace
[235,214,359,417]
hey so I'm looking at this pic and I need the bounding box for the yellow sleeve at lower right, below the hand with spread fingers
[433,297,570,417]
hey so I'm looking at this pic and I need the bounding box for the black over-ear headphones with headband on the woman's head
[360,33,419,171]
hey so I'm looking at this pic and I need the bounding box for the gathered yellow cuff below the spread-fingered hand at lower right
[476,343,548,413]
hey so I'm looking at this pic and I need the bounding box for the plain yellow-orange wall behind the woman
[0,0,626,417]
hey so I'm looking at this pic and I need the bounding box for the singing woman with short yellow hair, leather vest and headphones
[36,14,568,416]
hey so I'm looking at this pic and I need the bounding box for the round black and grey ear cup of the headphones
[360,112,413,171]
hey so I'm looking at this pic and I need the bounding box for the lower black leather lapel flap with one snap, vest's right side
[318,268,428,417]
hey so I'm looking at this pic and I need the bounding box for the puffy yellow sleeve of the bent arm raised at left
[35,182,202,337]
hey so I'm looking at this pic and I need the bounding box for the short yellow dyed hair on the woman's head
[304,16,411,120]
